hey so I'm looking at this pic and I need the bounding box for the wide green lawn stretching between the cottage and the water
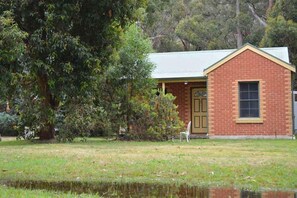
[0,139,297,190]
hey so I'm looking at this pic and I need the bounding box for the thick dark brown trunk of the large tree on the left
[38,74,58,140]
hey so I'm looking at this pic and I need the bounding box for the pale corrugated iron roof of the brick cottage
[149,47,290,79]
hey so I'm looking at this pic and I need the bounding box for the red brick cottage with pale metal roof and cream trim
[149,44,295,138]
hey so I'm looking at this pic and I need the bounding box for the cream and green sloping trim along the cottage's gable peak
[203,44,296,75]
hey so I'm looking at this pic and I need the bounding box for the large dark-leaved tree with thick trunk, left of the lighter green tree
[0,0,144,139]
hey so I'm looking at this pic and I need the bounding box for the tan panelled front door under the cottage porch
[191,88,207,134]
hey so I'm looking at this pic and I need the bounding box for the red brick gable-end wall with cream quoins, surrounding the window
[208,50,292,136]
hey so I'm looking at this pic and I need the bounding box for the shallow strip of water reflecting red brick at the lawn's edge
[0,181,297,198]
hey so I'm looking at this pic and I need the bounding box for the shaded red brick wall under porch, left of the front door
[159,82,206,127]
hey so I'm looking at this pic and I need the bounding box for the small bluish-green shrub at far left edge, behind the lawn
[0,112,18,136]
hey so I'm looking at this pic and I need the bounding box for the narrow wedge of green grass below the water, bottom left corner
[0,186,98,198]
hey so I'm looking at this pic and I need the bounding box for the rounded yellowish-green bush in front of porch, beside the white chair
[126,93,184,141]
